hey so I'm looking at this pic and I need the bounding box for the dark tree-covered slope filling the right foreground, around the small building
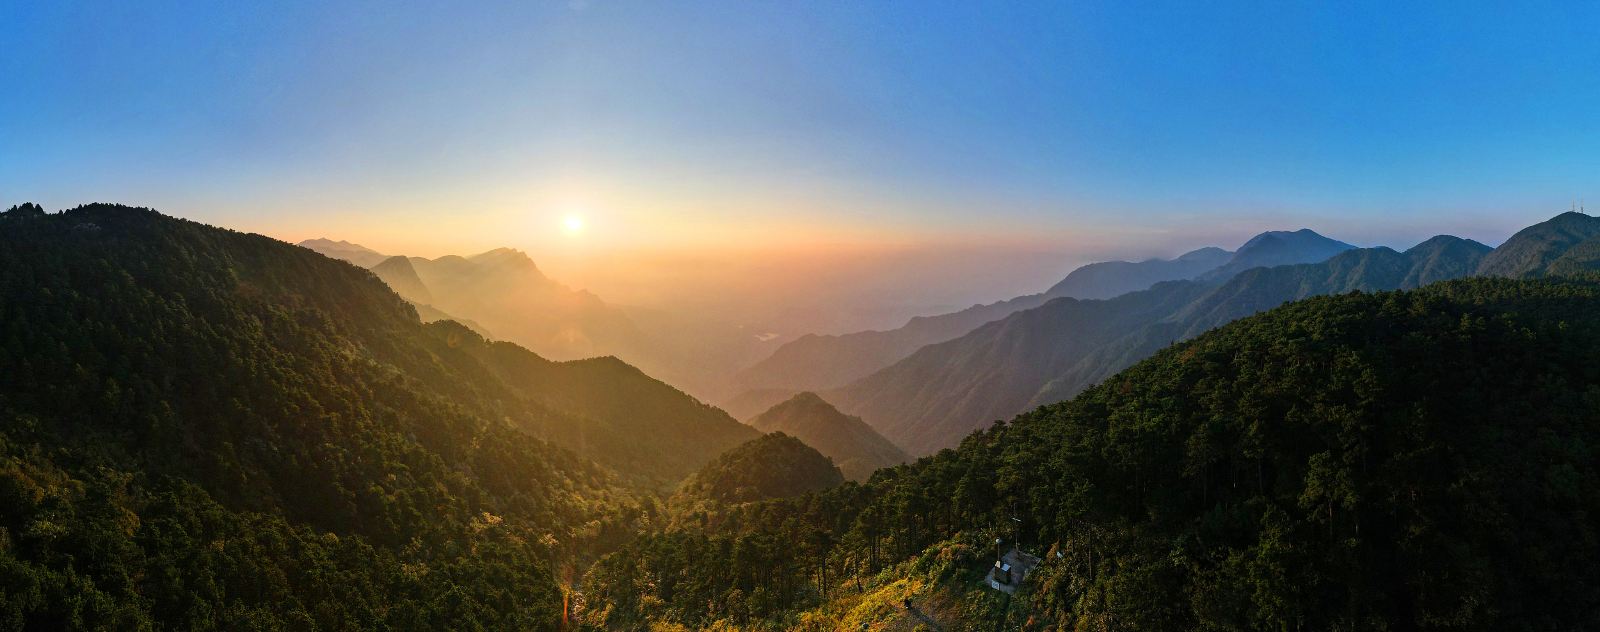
[584,277,1600,630]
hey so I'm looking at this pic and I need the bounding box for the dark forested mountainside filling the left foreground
[0,205,638,629]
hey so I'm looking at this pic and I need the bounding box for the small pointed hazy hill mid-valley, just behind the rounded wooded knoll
[750,392,910,480]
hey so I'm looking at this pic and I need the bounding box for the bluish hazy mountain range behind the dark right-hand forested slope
[822,213,1600,456]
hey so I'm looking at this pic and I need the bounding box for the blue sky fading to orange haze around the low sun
[0,0,1600,328]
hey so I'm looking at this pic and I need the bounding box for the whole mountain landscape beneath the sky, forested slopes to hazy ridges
[0,203,1600,630]
